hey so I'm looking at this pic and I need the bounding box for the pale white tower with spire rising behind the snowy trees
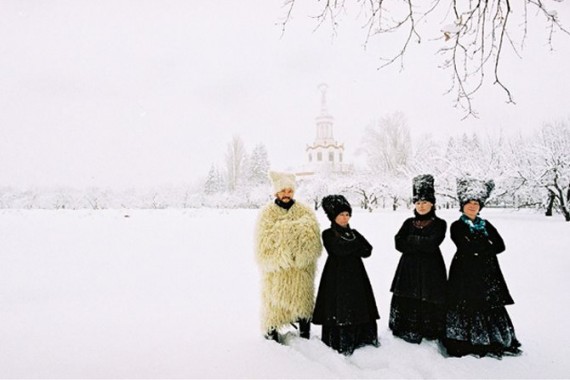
[305,83,344,172]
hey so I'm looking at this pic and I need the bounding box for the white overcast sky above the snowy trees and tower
[0,0,570,188]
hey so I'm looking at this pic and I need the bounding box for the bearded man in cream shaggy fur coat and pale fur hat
[256,172,322,342]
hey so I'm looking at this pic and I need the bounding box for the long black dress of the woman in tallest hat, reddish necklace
[388,209,447,343]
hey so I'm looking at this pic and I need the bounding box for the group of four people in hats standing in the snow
[256,172,521,357]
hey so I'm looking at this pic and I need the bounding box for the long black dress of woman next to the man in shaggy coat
[312,222,380,355]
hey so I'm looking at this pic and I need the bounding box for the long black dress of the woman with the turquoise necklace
[444,216,521,357]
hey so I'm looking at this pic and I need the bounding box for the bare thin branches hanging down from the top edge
[282,0,570,117]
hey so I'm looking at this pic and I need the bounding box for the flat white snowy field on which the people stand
[0,209,570,378]
